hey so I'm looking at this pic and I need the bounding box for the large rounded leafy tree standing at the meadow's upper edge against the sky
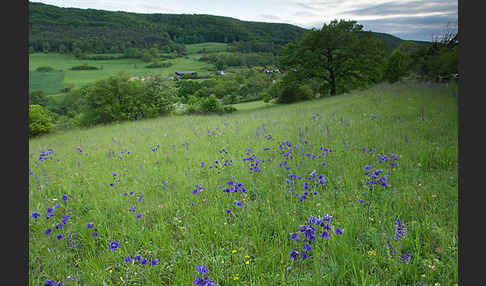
[280,20,385,96]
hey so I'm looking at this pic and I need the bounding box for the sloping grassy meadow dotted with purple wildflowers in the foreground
[28,81,458,286]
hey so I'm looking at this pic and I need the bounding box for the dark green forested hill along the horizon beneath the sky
[29,2,430,53]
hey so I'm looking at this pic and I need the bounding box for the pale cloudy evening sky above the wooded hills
[32,0,458,41]
